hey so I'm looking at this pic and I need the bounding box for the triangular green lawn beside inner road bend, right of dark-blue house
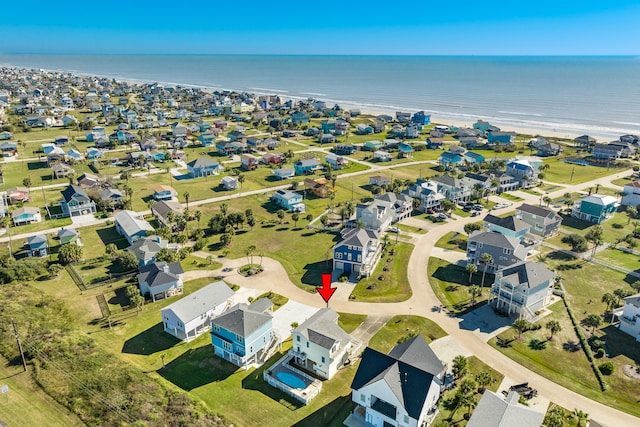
[350,243,413,302]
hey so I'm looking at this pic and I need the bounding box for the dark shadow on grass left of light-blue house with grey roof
[157,346,239,391]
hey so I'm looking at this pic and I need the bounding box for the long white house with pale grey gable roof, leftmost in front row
[160,281,234,342]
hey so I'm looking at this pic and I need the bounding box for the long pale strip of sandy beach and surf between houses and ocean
[0,63,640,143]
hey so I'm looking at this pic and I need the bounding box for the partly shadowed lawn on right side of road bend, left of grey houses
[427,257,493,313]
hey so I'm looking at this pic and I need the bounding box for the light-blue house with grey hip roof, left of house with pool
[211,298,278,369]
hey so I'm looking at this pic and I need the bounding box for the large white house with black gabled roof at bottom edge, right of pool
[344,335,445,427]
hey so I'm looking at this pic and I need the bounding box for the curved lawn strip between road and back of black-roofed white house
[369,315,447,354]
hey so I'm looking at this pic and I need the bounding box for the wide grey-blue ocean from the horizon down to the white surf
[0,55,640,137]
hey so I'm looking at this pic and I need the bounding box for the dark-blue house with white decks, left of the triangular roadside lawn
[333,228,382,277]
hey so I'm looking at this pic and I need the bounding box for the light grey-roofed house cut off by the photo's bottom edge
[467,390,545,427]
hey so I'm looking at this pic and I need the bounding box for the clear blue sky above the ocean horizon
[0,0,640,55]
